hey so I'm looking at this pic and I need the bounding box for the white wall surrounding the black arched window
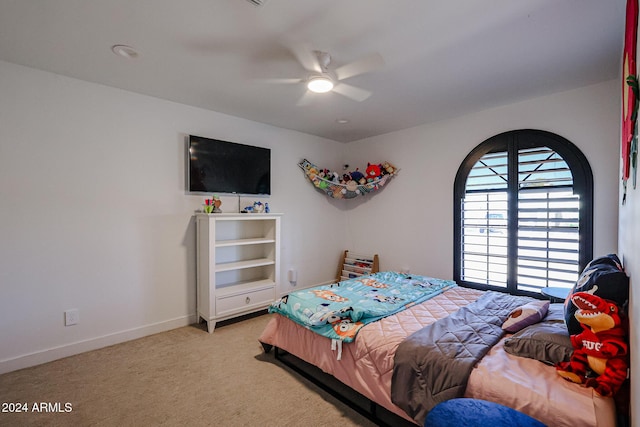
[345,81,620,278]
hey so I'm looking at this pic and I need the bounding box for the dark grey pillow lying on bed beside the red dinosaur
[504,320,573,365]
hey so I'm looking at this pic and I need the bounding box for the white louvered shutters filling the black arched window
[459,142,580,292]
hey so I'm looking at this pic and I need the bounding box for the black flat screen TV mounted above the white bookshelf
[187,135,271,195]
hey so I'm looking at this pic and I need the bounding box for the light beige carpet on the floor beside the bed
[0,315,375,427]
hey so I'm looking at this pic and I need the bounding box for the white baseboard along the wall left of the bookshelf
[0,314,197,374]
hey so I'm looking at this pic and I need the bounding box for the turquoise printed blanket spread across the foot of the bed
[269,271,456,342]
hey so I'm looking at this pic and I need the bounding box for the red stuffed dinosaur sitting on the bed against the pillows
[556,292,629,396]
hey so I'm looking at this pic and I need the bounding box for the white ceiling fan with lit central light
[262,46,384,105]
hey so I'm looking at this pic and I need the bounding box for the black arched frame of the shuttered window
[453,129,593,296]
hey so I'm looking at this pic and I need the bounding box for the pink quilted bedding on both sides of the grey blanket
[259,287,615,427]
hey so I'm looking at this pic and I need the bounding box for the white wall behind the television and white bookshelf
[0,62,346,373]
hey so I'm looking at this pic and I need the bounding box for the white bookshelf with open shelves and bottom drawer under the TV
[196,213,282,333]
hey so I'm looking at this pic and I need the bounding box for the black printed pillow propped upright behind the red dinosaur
[564,254,629,335]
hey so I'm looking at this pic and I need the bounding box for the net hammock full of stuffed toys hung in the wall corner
[298,159,399,199]
